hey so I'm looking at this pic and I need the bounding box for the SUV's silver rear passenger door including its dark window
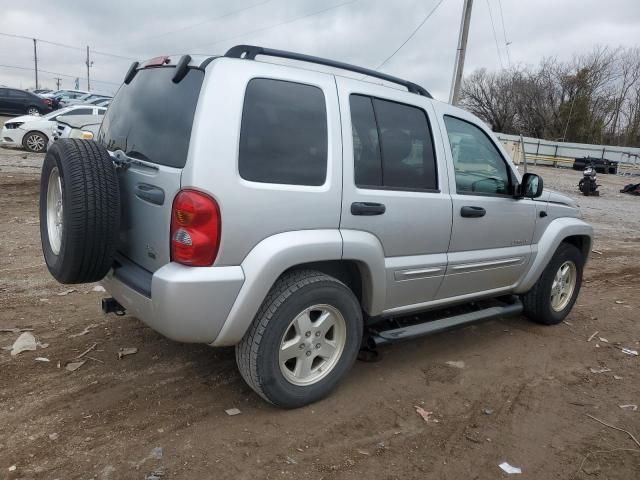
[336,77,452,314]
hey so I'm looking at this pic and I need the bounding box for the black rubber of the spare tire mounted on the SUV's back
[40,139,120,283]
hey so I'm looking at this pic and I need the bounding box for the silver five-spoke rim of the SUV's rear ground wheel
[278,305,347,386]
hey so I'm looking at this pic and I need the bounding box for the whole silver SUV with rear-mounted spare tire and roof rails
[40,46,592,407]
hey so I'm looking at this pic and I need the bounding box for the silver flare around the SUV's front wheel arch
[515,217,593,294]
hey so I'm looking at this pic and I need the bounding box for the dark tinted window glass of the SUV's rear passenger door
[350,95,438,190]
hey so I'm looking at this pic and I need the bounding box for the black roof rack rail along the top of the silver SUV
[224,45,433,98]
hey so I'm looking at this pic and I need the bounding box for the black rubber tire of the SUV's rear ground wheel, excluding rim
[236,270,362,408]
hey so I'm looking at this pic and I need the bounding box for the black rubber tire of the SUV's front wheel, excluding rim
[522,243,584,325]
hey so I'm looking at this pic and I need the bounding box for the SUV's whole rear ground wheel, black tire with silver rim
[236,270,362,408]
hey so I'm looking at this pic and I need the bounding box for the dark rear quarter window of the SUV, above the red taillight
[239,78,328,185]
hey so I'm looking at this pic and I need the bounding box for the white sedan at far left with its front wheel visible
[0,105,107,153]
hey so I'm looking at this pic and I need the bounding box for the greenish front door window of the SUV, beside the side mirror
[444,116,511,195]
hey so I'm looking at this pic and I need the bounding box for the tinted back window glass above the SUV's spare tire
[98,67,204,168]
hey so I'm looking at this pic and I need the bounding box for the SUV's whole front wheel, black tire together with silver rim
[522,243,584,325]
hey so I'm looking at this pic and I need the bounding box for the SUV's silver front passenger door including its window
[437,104,536,299]
